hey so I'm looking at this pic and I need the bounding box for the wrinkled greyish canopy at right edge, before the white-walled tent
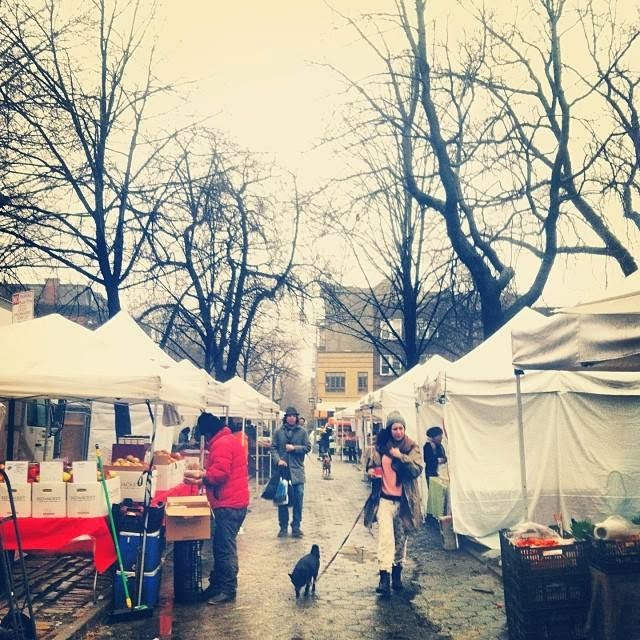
[513,271,640,371]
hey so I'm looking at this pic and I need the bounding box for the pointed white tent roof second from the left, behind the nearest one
[94,311,209,408]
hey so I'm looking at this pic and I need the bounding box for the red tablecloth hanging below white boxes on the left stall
[2,517,116,573]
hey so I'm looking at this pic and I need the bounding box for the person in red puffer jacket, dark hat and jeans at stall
[192,413,249,605]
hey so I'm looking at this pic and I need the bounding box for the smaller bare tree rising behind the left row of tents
[141,130,303,381]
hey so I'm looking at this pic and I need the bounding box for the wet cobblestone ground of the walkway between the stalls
[83,457,506,640]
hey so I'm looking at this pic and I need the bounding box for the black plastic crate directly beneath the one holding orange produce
[503,571,591,611]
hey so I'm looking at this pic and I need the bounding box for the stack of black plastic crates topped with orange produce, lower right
[500,530,591,640]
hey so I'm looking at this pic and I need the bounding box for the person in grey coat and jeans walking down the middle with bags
[271,407,311,538]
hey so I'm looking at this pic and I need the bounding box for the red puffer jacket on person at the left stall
[205,427,249,509]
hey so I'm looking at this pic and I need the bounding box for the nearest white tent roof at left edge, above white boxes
[0,314,161,402]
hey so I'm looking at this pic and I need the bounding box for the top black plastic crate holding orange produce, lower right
[500,529,589,579]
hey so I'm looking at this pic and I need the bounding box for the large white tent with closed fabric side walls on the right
[435,309,640,542]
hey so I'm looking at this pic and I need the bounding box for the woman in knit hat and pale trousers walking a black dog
[367,411,423,597]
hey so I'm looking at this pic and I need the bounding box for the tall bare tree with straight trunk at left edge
[0,0,174,315]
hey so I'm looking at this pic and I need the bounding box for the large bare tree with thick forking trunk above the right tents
[332,0,636,335]
